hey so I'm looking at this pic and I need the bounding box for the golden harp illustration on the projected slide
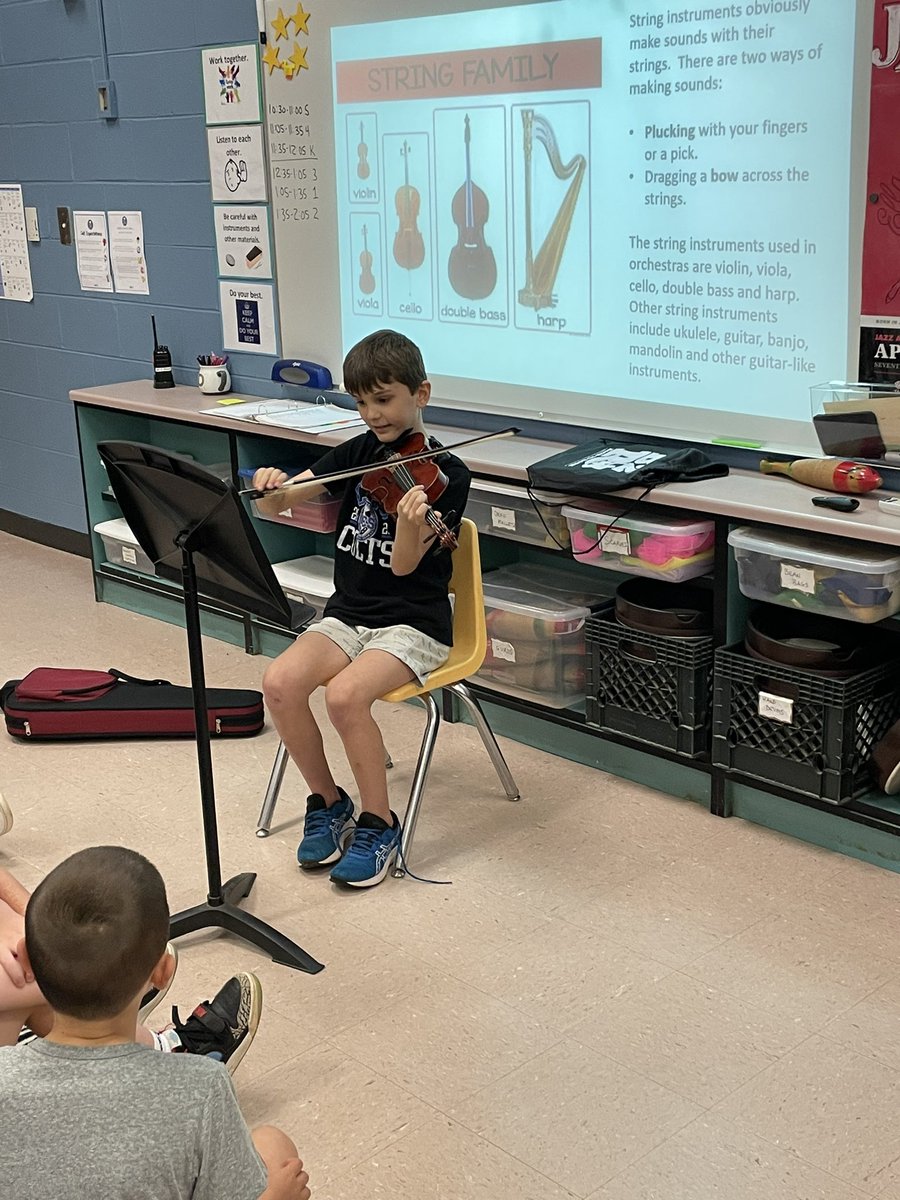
[518,108,588,311]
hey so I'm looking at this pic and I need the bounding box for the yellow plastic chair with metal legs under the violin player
[257,517,520,878]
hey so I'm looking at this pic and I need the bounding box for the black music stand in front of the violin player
[97,442,323,974]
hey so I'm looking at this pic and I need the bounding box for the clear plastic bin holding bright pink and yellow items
[563,500,715,583]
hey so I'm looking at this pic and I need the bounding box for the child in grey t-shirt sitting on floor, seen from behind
[0,846,310,1200]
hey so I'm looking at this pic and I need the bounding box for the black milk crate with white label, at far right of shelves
[713,646,900,804]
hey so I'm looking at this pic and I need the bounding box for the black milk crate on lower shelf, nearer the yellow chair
[584,613,713,758]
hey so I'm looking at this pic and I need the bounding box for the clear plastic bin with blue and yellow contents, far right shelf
[728,526,900,623]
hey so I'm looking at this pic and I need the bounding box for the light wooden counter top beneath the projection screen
[70,379,900,546]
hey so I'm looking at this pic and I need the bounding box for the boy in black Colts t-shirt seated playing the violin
[253,330,469,888]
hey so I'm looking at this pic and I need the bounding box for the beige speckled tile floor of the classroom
[0,535,900,1200]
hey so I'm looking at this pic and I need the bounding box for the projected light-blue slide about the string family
[332,0,854,416]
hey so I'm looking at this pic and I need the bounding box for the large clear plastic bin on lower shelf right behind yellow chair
[475,564,612,708]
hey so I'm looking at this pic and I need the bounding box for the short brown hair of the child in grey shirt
[25,846,169,1021]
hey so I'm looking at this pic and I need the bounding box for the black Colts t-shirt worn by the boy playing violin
[312,432,470,646]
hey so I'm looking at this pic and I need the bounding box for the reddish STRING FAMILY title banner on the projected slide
[337,37,601,104]
